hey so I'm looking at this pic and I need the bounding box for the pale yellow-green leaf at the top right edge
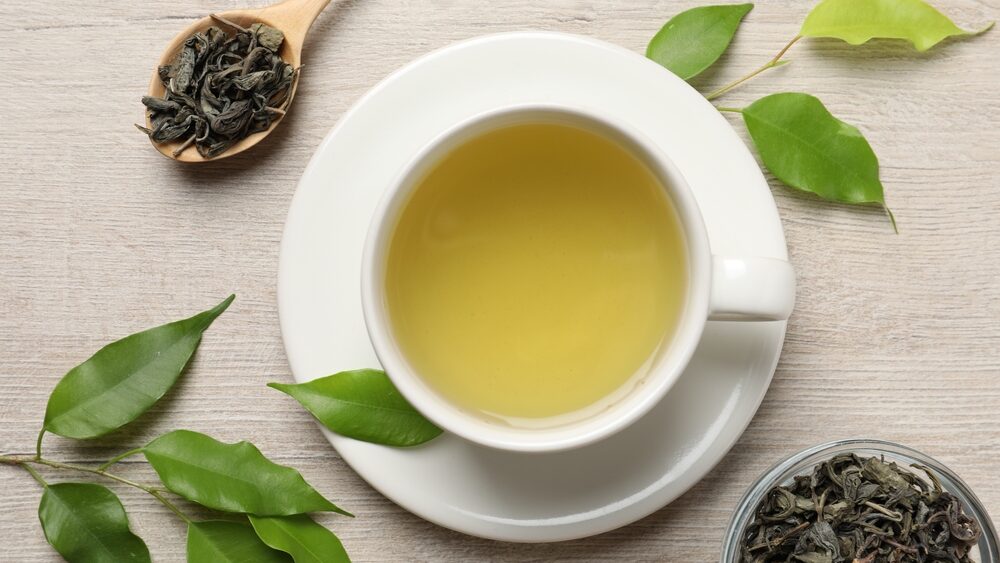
[799,0,993,51]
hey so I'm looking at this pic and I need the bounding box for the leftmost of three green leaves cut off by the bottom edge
[38,483,150,563]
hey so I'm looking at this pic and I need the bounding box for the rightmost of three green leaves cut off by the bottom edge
[250,514,351,563]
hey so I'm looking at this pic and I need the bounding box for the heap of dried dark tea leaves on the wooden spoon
[136,15,298,158]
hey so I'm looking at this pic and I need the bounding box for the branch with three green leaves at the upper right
[646,0,993,232]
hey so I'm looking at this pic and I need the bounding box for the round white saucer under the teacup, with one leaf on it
[278,32,787,542]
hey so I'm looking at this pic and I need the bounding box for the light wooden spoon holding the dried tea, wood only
[146,0,330,162]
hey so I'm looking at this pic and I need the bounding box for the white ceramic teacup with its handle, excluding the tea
[361,104,795,452]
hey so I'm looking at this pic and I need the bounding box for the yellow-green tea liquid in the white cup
[385,123,687,424]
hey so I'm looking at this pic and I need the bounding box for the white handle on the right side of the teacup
[708,256,795,321]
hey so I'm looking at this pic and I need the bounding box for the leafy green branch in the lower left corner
[0,296,351,563]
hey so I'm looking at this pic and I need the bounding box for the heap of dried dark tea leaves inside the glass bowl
[740,454,982,563]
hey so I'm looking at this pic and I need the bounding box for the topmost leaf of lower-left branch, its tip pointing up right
[45,295,236,439]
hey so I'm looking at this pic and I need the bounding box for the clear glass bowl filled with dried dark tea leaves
[722,440,1000,563]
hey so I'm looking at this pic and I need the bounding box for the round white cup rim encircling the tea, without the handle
[361,102,712,453]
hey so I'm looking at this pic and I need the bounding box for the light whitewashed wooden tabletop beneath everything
[0,0,1000,562]
